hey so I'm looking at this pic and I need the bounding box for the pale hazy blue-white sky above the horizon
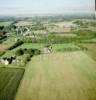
[0,0,95,15]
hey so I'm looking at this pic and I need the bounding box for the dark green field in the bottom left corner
[0,68,24,100]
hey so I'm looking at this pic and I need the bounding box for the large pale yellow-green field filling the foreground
[15,51,96,100]
